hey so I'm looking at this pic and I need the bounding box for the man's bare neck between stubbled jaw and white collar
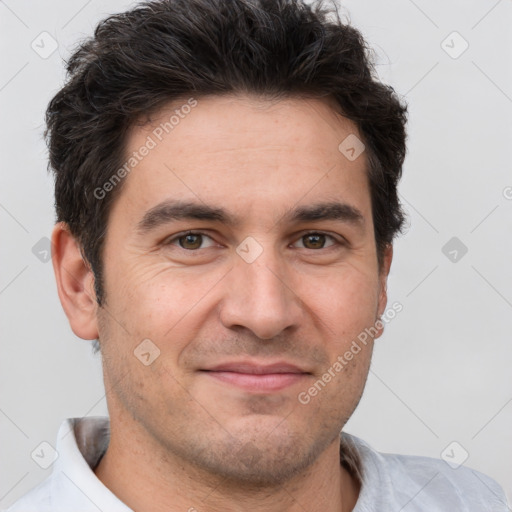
[95,425,360,512]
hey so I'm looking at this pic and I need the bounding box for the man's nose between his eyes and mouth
[220,250,302,340]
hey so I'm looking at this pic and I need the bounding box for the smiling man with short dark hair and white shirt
[9,0,507,512]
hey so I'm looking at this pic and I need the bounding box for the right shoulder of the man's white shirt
[343,434,509,512]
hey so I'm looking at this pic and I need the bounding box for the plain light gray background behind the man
[0,0,512,508]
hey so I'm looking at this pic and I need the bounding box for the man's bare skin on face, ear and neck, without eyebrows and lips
[53,95,392,512]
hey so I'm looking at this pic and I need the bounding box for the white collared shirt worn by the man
[7,417,510,512]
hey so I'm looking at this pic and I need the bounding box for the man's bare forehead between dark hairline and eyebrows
[112,95,369,226]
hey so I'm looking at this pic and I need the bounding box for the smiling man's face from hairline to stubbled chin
[97,96,390,483]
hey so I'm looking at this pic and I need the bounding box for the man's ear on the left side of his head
[52,222,98,340]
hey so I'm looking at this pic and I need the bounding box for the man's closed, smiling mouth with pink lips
[201,361,312,393]
